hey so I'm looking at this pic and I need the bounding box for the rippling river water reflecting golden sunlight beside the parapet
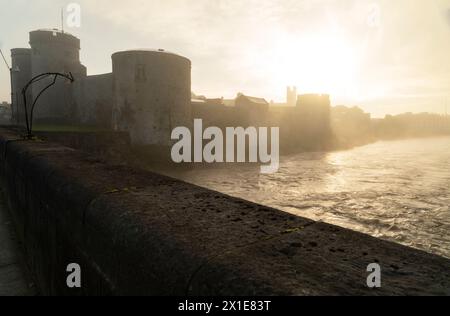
[158,137,450,258]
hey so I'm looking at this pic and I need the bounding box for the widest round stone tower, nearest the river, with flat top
[112,50,192,146]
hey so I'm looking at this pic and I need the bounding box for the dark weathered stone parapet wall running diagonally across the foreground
[0,130,450,295]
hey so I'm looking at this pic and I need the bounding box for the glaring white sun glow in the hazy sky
[266,33,359,99]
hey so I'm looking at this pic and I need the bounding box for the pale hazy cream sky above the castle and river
[0,0,450,117]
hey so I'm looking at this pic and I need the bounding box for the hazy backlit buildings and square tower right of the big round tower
[192,88,333,152]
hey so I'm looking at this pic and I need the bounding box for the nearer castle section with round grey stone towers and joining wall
[11,30,192,145]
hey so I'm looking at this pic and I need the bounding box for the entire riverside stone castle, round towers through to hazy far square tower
[11,29,331,149]
